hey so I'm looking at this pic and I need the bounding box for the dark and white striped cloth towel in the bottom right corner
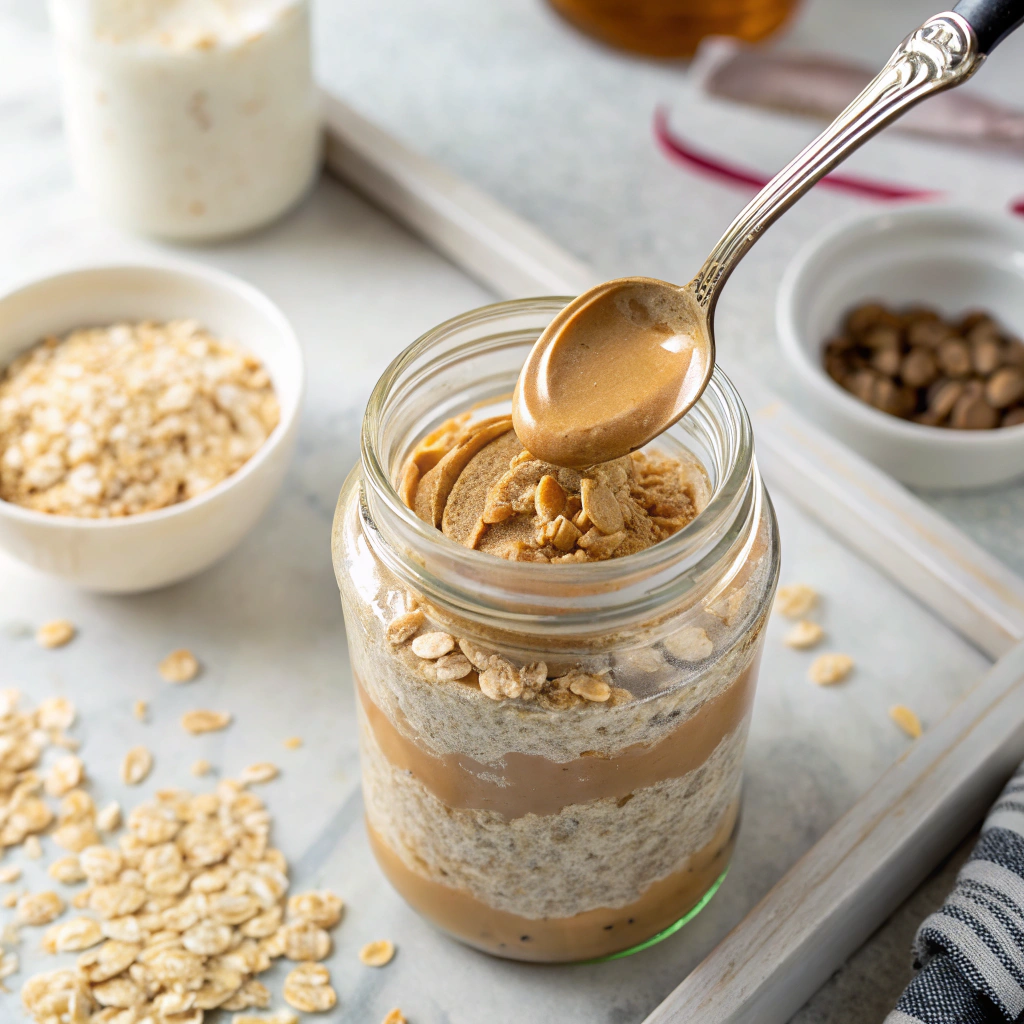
[886,765,1024,1024]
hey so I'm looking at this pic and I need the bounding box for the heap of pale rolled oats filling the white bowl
[0,319,280,518]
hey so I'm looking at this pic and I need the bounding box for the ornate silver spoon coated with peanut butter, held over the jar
[512,0,1024,468]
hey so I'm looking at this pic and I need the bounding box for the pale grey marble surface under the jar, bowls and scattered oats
[0,0,1024,1024]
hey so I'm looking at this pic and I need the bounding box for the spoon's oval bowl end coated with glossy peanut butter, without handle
[512,278,715,469]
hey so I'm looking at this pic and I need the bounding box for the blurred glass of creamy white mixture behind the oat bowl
[49,0,319,241]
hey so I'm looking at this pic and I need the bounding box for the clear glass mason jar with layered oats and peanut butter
[333,298,779,962]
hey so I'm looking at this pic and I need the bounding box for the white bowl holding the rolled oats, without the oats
[0,263,303,593]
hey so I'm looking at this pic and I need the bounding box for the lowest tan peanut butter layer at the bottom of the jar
[367,801,739,964]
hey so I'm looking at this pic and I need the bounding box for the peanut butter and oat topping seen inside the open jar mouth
[399,417,708,562]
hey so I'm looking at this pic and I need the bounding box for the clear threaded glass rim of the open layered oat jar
[360,296,760,631]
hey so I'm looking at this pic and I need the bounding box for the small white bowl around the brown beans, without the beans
[776,205,1024,490]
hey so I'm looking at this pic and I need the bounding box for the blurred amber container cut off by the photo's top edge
[551,0,797,57]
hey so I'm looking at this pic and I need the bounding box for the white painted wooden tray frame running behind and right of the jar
[325,90,1024,1024]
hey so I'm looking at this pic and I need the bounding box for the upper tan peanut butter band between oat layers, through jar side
[356,659,758,820]
